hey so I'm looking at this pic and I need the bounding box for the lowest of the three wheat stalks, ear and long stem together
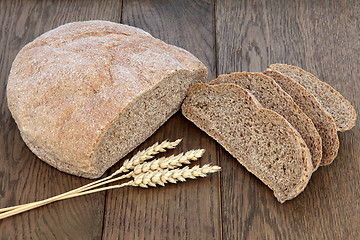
[0,164,221,219]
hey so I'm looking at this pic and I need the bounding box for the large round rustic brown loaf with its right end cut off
[7,21,207,178]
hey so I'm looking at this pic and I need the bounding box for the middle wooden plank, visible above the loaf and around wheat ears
[103,0,221,239]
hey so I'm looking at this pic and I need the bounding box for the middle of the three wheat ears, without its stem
[132,149,205,176]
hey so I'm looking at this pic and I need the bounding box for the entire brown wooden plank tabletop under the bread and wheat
[0,0,360,239]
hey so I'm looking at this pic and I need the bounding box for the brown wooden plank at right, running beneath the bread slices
[215,0,360,239]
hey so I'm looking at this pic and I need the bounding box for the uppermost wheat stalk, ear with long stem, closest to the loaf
[0,139,182,213]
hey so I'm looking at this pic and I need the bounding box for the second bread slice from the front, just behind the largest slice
[210,72,322,171]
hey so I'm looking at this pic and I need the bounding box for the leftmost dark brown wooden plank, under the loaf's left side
[0,0,121,239]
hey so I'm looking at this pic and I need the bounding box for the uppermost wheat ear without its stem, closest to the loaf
[112,139,182,176]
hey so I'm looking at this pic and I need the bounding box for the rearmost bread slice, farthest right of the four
[269,64,356,132]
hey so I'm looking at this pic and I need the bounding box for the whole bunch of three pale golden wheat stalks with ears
[0,139,220,219]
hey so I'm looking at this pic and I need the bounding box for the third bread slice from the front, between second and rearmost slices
[263,70,339,166]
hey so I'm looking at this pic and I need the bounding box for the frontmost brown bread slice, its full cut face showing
[182,83,313,203]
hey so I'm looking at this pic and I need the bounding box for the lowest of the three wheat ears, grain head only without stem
[132,164,221,188]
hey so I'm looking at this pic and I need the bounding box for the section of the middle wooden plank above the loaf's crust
[122,0,215,80]
